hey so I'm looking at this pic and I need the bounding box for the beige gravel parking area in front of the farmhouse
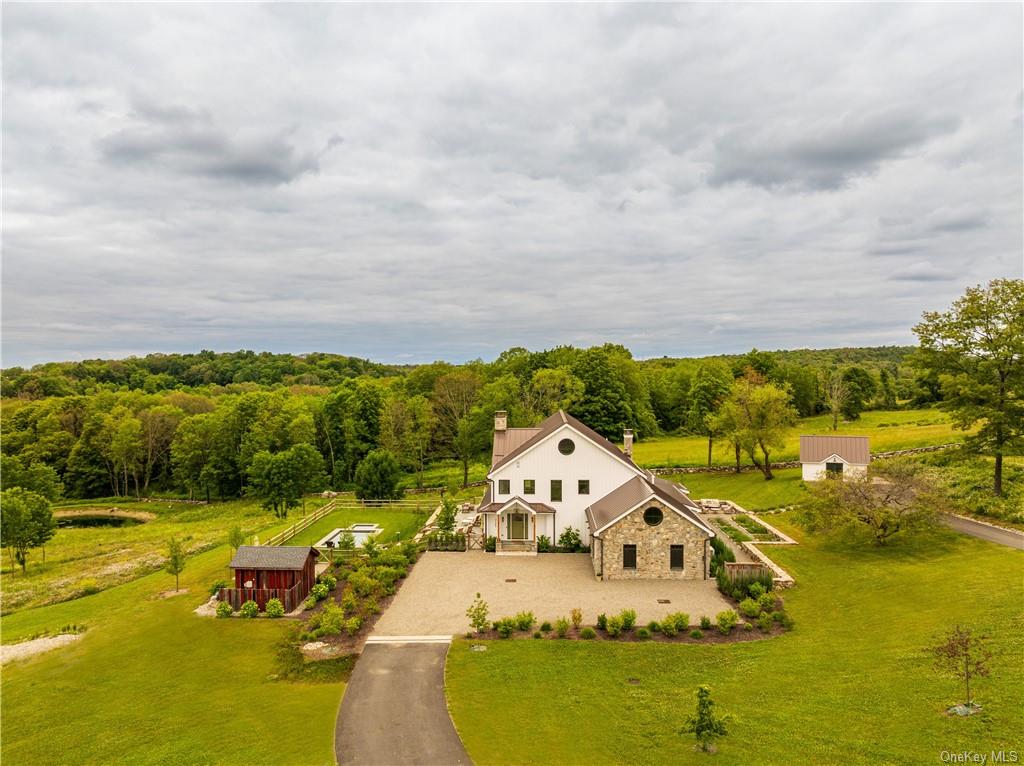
[374,551,729,636]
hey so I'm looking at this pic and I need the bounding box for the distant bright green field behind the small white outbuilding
[633,410,964,467]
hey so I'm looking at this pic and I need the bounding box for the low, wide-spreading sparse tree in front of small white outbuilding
[800,460,941,545]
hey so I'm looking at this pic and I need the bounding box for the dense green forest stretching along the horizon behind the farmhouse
[2,344,940,499]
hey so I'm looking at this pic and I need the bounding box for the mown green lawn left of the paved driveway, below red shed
[0,529,344,766]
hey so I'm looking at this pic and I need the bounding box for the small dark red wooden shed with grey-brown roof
[217,545,319,611]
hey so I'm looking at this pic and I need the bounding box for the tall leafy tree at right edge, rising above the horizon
[913,280,1024,496]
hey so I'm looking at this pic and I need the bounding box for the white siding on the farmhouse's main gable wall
[489,426,637,545]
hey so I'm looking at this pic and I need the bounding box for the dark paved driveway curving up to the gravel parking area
[334,643,472,766]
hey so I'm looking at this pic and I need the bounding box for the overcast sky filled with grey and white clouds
[2,3,1024,367]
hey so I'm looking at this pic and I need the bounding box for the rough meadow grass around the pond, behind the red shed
[0,498,294,613]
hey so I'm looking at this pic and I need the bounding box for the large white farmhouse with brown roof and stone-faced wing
[478,411,714,580]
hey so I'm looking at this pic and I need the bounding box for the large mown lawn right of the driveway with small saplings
[446,515,1024,766]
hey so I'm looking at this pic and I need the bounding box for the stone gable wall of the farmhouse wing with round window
[594,500,711,580]
